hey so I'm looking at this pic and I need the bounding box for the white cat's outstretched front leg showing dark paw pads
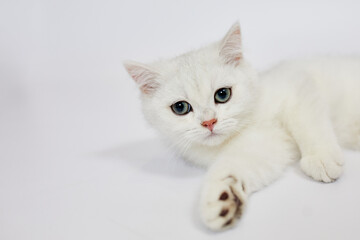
[200,126,298,230]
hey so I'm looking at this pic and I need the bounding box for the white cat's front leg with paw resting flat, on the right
[285,84,343,182]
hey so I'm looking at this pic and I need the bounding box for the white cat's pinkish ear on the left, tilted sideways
[124,61,160,94]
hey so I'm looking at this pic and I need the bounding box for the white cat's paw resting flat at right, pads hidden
[300,156,343,183]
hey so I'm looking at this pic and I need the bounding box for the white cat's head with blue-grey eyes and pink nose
[124,23,257,149]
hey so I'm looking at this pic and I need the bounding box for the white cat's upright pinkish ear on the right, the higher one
[220,22,243,66]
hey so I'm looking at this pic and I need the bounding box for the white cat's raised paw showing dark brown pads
[201,176,245,231]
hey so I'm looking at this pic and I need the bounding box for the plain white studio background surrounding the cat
[0,0,360,240]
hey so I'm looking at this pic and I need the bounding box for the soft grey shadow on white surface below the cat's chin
[96,139,204,178]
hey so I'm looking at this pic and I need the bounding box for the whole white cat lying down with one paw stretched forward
[124,23,360,230]
